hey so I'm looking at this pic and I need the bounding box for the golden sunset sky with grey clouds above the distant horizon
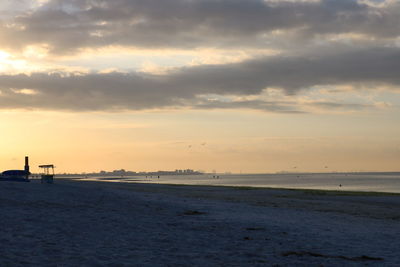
[0,0,400,173]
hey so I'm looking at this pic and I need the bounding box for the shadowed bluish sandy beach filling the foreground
[0,180,400,266]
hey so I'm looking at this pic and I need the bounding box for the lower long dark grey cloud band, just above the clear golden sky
[0,48,400,112]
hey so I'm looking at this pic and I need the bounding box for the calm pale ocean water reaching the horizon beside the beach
[75,173,400,193]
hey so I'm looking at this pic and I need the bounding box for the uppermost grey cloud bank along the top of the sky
[0,0,400,53]
